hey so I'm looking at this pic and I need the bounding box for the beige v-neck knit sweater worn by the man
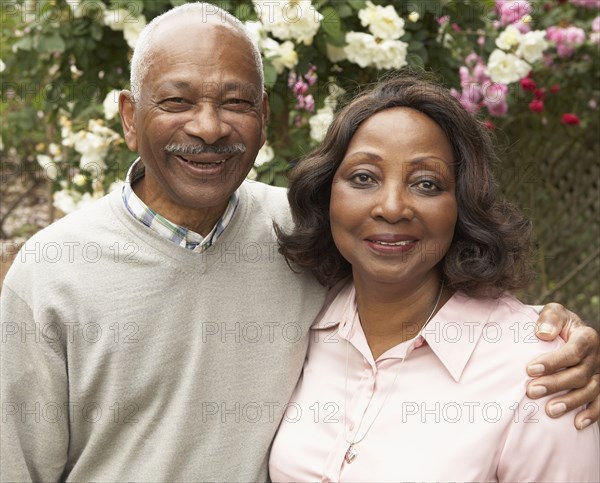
[0,181,325,482]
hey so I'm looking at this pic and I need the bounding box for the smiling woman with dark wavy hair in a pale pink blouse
[270,76,600,481]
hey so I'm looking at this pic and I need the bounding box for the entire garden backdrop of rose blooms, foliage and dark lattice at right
[0,0,600,321]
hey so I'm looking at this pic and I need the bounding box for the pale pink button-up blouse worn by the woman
[269,284,600,482]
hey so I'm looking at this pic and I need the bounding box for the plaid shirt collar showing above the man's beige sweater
[122,158,240,252]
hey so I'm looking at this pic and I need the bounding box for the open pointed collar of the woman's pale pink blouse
[311,281,498,382]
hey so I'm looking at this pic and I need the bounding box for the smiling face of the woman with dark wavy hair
[329,107,457,286]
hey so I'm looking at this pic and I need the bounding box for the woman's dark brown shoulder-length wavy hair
[275,74,531,296]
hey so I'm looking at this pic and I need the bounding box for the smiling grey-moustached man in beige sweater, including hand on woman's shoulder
[2,4,597,481]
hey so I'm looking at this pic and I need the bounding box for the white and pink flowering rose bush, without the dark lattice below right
[0,0,600,211]
